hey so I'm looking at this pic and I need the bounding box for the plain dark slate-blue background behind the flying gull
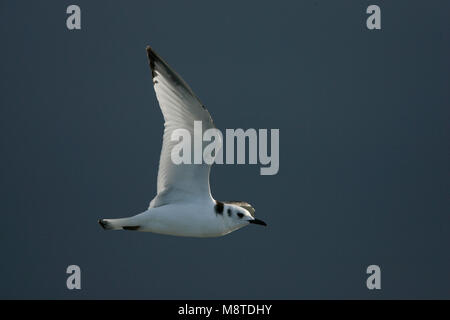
[0,0,450,299]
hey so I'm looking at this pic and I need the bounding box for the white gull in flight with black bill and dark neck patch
[98,47,266,237]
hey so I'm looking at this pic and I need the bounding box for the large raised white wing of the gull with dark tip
[147,47,222,208]
